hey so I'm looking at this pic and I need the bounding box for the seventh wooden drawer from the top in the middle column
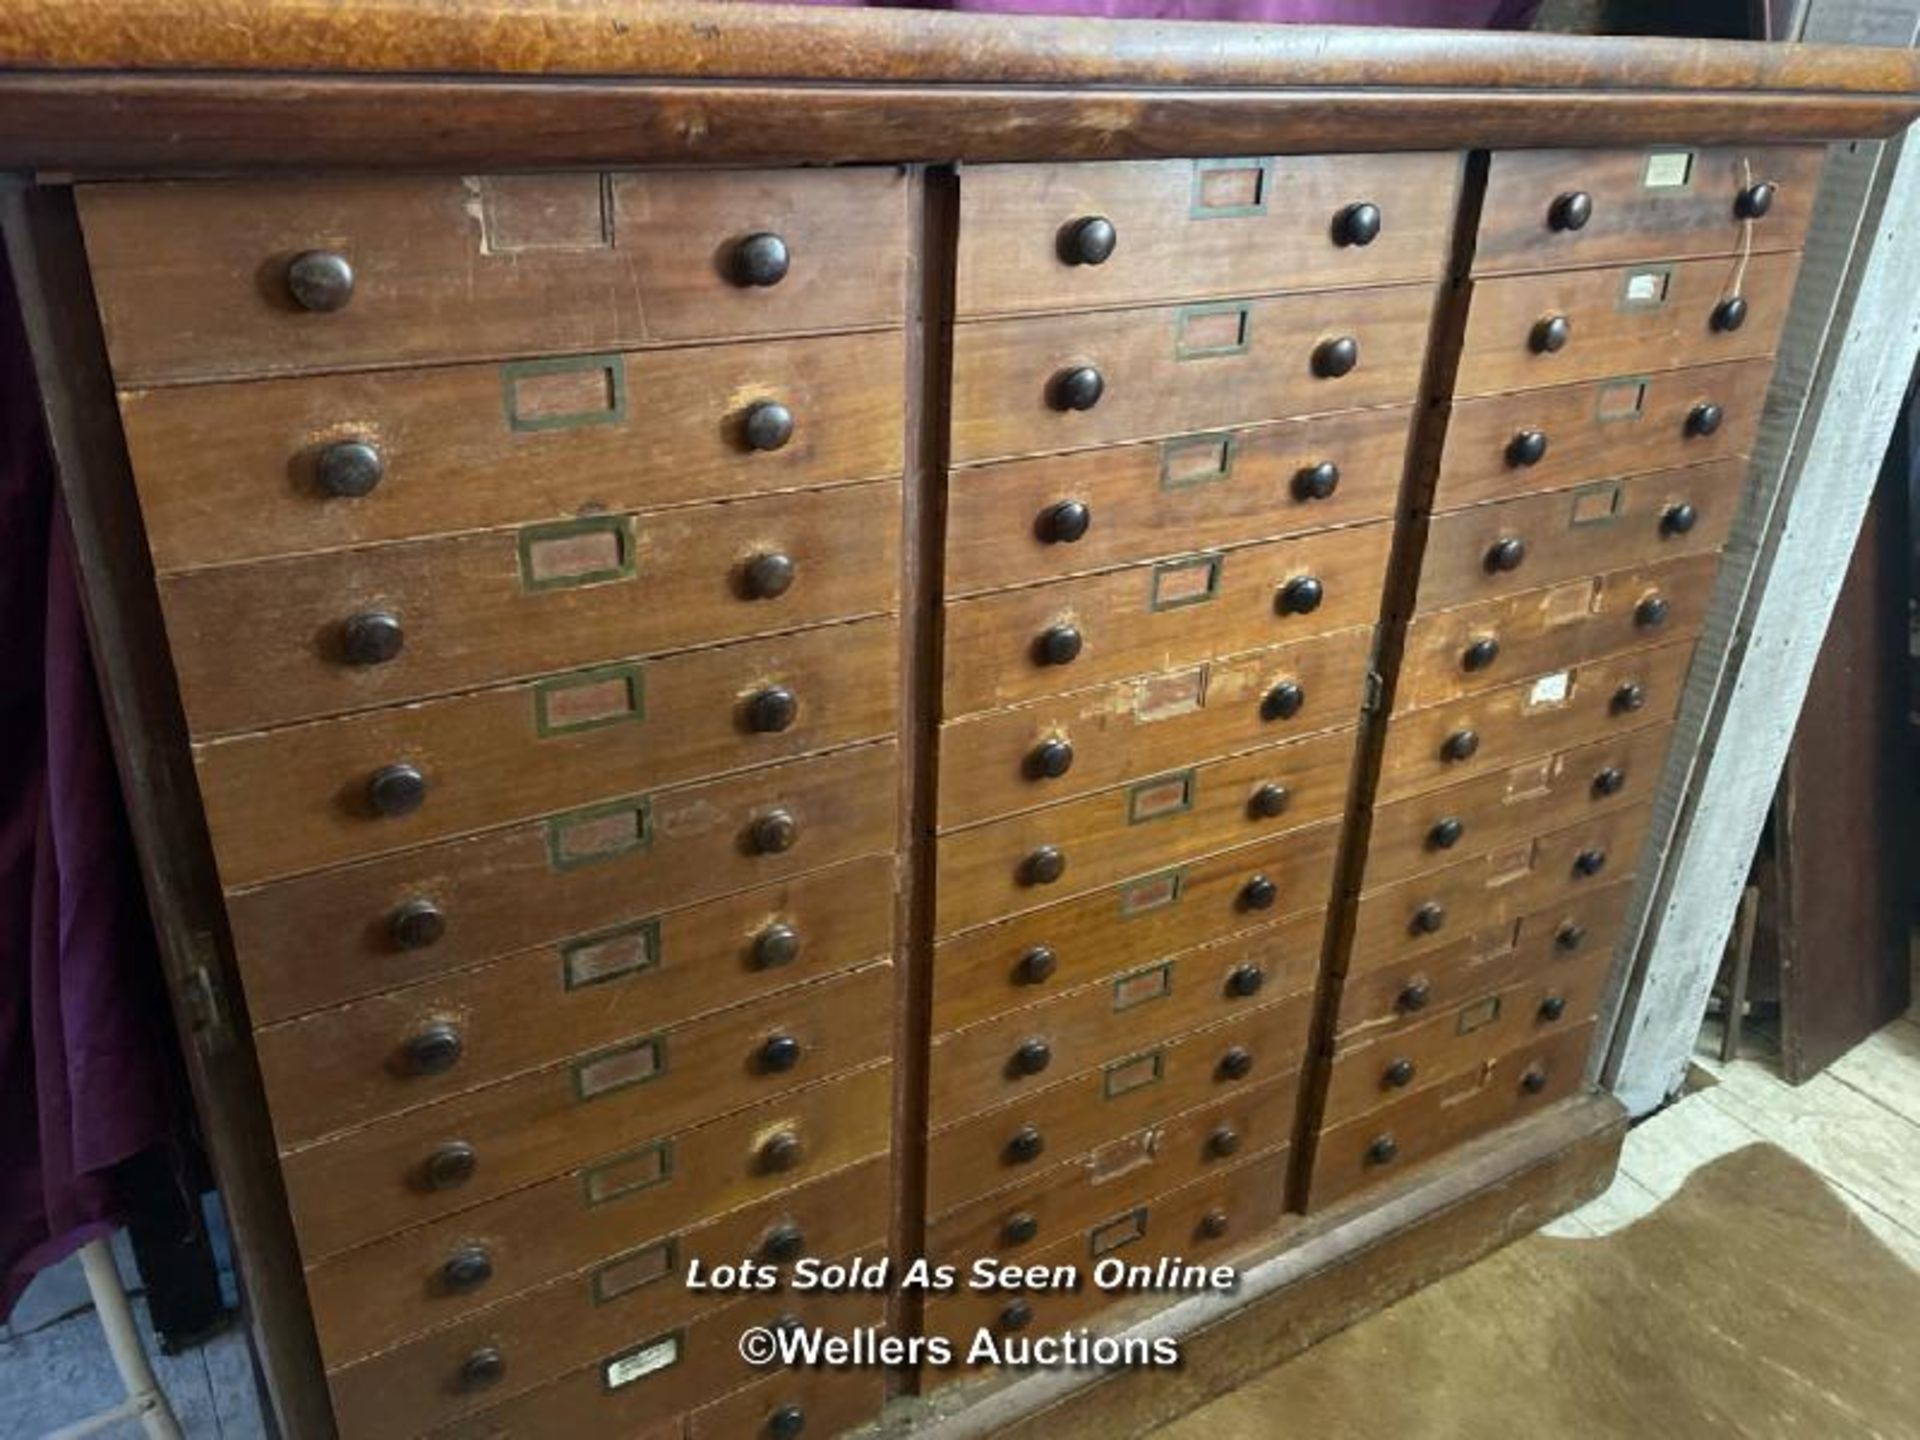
[933,822,1340,1029]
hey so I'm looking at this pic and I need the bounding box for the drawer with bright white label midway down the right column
[1375,639,1693,804]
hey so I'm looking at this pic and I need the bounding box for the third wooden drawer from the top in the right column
[1432,359,1774,511]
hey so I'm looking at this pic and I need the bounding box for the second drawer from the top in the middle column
[950,284,1434,465]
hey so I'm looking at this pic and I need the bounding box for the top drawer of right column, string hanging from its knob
[1473,146,1826,275]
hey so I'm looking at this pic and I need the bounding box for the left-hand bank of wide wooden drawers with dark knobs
[81,169,906,1436]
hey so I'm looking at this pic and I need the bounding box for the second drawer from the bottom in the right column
[1321,956,1613,1127]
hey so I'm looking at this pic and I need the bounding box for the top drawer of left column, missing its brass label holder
[79,167,906,384]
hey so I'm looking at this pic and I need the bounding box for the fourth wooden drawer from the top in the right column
[1415,459,1747,611]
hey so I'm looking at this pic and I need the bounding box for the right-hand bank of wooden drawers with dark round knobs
[1308,148,1820,1208]
